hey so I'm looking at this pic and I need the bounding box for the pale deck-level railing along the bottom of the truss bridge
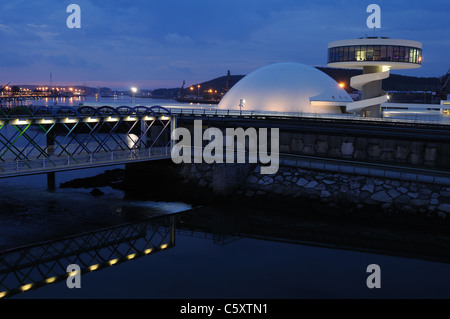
[0,147,171,177]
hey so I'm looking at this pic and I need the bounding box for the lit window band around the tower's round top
[328,45,422,64]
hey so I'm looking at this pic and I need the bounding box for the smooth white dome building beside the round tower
[218,63,353,114]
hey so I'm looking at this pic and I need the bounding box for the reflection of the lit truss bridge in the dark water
[0,216,176,299]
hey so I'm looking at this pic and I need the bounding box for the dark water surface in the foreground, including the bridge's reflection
[0,170,450,299]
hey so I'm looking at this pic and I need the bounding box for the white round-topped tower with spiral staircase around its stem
[328,37,422,117]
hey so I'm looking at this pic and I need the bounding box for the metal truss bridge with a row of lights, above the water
[0,106,176,178]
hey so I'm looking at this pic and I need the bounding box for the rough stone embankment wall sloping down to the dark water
[175,164,450,218]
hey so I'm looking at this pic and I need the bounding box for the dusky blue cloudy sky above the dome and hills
[0,0,450,88]
